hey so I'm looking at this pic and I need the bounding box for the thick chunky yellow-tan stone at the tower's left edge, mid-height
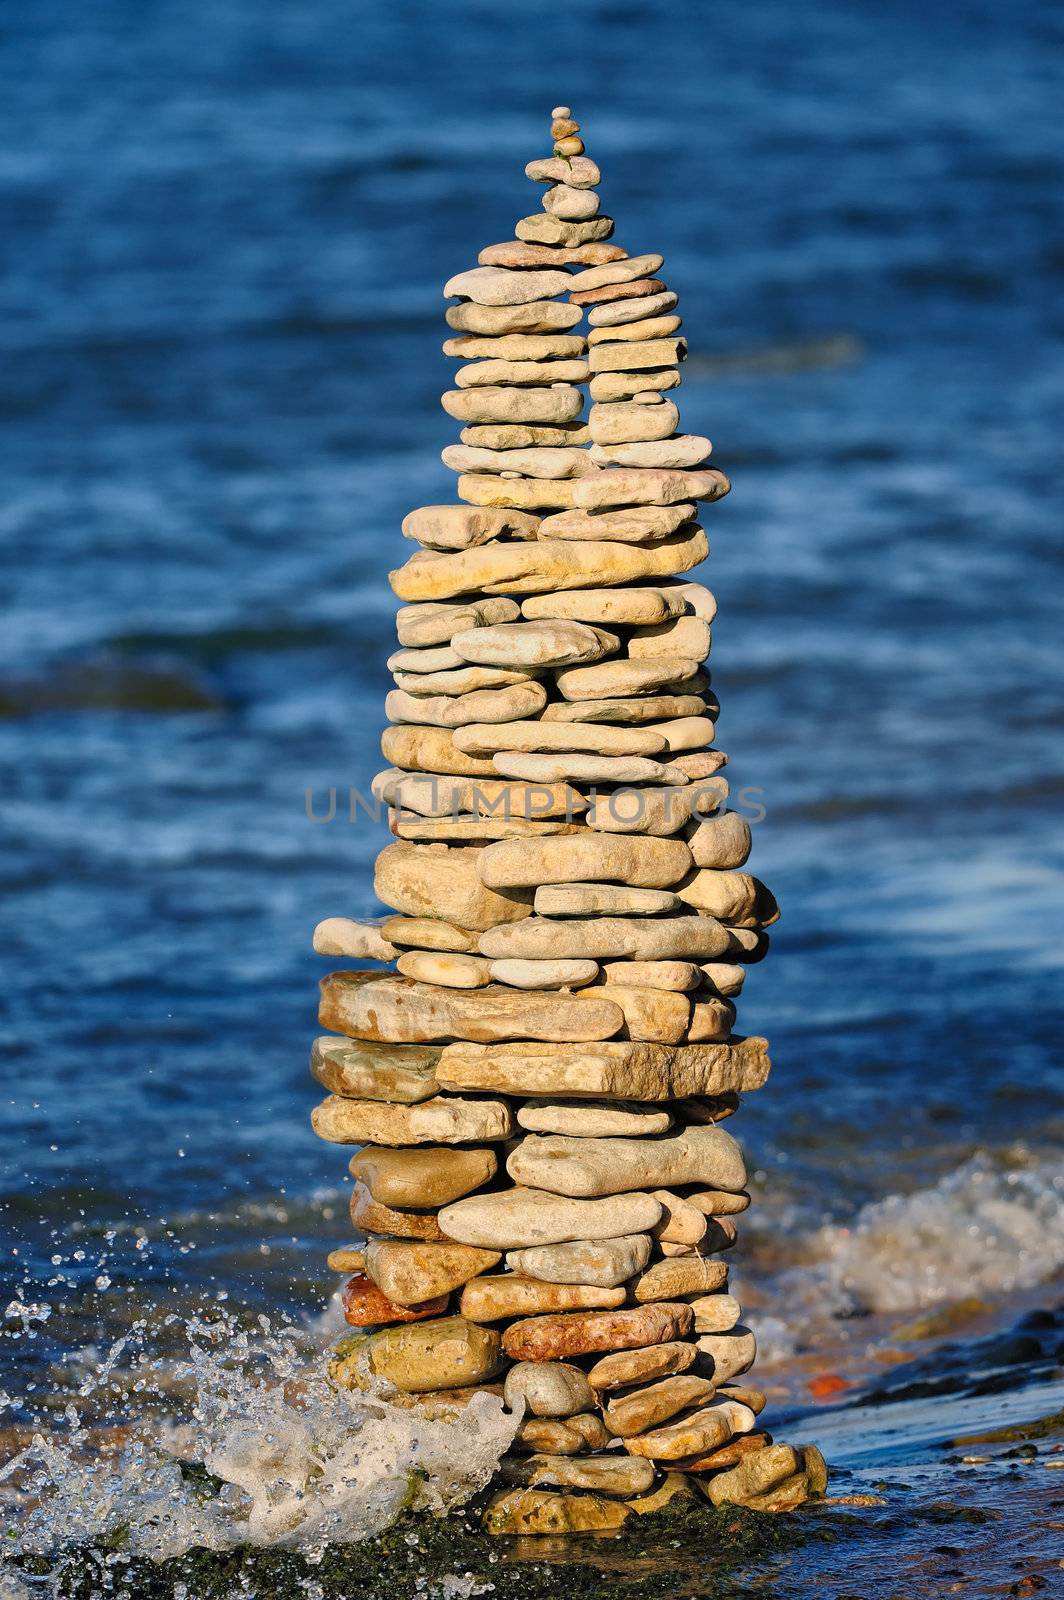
[373,843,531,934]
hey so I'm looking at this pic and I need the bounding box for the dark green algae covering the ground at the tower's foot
[24,1494,842,1600]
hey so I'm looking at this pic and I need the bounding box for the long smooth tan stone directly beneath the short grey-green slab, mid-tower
[480,915,731,962]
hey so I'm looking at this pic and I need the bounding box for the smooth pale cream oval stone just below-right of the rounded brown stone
[438,1189,661,1248]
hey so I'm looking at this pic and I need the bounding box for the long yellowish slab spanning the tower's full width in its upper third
[389,528,709,601]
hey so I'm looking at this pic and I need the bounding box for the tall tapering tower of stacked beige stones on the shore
[312,107,826,1533]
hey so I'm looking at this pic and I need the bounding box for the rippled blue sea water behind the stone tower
[0,0,1064,1427]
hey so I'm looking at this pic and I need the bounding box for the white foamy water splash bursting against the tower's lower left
[0,1315,520,1560]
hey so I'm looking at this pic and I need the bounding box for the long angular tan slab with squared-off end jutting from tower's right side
[437,1037,770,1100]
